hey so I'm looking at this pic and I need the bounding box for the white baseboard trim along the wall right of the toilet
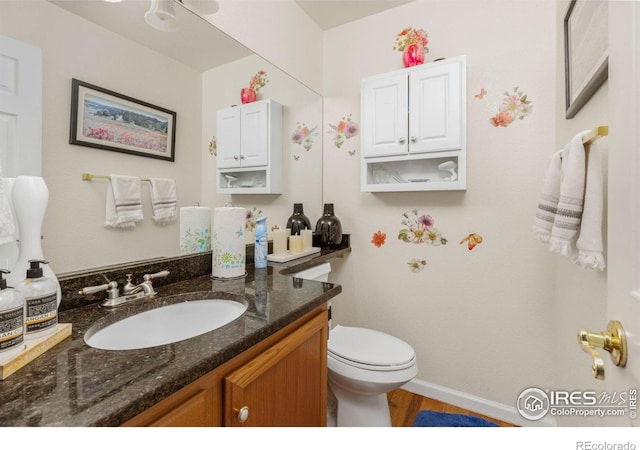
[402,379,556,427]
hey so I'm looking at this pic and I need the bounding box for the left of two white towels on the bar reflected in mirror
[104,175,142,228]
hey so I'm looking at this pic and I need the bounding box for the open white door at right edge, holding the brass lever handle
[602,2,640,426]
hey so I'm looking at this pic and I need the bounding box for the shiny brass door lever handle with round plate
[578,320,627,380]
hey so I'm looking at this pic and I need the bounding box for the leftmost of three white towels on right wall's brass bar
[533,150,562,242]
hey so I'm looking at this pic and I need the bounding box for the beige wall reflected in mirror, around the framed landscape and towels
[0,1,202,274]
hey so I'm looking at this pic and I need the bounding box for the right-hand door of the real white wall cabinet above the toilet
[409,57,467,153]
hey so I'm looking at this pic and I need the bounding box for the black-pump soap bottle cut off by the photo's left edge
[0,269,24,361]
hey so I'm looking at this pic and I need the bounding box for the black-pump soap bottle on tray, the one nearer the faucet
[16,259,58,341]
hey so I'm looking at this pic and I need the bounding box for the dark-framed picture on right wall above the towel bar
[564,0,609,119]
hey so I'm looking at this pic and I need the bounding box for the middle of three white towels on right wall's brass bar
[549,130,591,256]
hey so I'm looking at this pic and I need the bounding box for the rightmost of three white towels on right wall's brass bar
[575,141,605,270]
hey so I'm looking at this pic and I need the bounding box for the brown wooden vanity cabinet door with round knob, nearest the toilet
[224,314,328,427]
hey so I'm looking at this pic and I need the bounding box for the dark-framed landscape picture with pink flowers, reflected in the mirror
[69,78,176,162]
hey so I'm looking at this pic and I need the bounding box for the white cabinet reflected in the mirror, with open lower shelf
[216,99,282,194]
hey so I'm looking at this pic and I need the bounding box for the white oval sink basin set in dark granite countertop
[84,299,247,350]
